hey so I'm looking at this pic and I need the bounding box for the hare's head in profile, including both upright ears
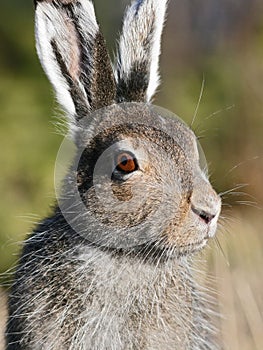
[36,0,221,257]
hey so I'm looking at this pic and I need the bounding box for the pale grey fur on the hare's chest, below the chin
[64,252,199,350]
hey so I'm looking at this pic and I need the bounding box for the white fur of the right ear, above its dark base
[115,0,167,101]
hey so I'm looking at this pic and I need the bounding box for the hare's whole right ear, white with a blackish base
[115,0,167,101]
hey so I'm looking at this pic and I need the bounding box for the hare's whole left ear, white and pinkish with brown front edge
[35,0,116,127]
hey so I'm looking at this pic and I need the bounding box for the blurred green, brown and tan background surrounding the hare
[0,0,263,350]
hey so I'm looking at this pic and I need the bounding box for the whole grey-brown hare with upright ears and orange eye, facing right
[6,0,221,350]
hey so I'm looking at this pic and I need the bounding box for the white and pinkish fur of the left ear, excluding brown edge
[35,0,99,126]
